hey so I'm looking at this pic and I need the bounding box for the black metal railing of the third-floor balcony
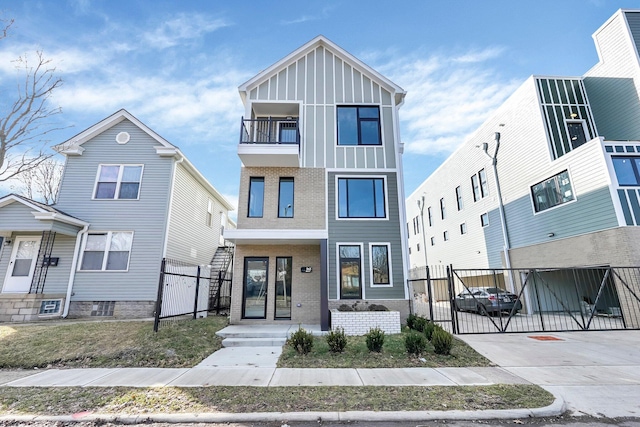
[240,117,300,146]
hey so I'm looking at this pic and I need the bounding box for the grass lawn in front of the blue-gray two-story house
[0,316,227,369]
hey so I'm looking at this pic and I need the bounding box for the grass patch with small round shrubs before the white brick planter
[278,328,492,368]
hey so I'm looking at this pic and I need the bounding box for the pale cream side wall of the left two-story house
[167,164,226,265]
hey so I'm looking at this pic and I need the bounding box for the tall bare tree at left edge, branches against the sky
[0,20,62,182]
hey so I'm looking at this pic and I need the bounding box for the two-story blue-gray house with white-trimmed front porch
[0,110,233,321]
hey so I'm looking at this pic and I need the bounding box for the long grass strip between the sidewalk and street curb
[0,384,554,415]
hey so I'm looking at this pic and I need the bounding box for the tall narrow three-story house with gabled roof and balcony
[225,36,409,328]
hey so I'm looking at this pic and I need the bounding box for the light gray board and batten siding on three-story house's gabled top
[248,46,396,169]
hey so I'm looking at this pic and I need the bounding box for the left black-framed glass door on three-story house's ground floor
[242,257,269,319]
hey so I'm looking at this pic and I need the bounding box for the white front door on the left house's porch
[2,237,40,294]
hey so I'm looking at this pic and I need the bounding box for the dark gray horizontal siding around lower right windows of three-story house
[327,172,405,299]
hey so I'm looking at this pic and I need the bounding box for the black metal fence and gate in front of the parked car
[409,266,640,334]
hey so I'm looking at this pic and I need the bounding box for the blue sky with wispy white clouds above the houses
[0,0,640,214]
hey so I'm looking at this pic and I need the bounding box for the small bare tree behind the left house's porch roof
[18,159,64,205]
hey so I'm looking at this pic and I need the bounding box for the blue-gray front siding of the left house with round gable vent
[56,120,174,301]
